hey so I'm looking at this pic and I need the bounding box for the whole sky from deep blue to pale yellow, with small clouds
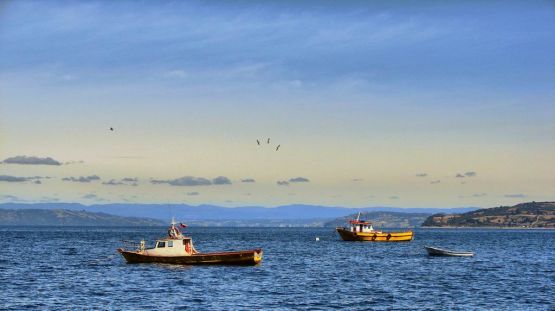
[0,1,555,207]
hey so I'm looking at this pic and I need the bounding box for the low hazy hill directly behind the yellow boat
[324,212,431,228]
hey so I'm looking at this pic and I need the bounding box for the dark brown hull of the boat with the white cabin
[118,249,262,266]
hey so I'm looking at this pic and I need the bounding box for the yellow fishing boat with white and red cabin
[336,213,414,242]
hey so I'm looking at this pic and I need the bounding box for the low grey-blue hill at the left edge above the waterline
[0,209,167,226]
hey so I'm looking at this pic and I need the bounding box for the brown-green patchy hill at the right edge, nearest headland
[422,202,555,228]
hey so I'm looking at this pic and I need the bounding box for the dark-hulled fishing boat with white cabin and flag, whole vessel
[117,219,262,265]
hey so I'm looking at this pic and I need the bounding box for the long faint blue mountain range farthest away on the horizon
[0,203,477,223]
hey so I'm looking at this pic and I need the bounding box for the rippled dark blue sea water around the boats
[0,227,555,310]
